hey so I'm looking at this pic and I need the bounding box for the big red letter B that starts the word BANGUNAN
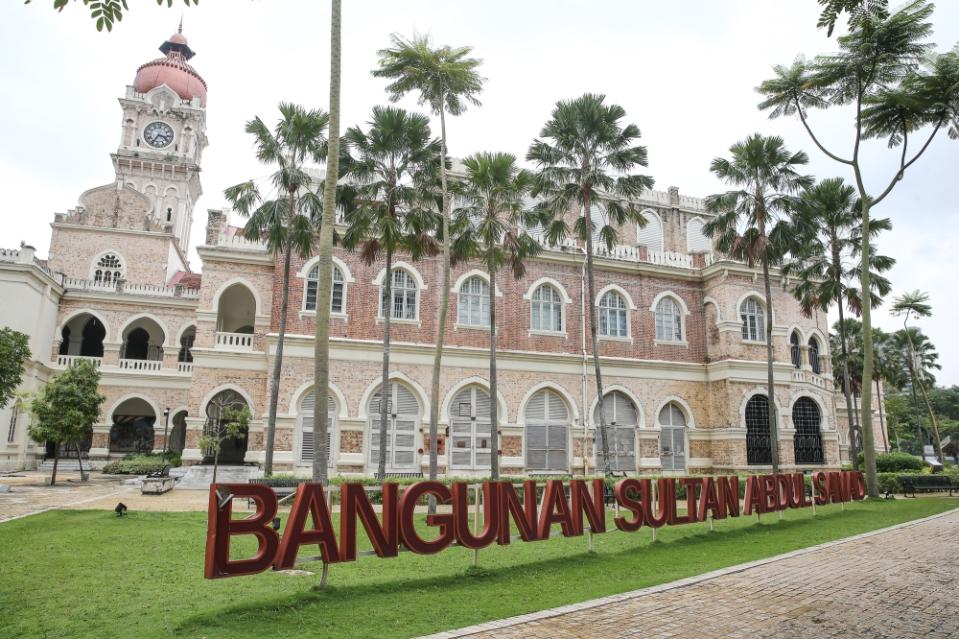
[203,484,280,579]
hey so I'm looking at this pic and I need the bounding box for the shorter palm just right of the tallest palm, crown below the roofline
[454,153,541,479]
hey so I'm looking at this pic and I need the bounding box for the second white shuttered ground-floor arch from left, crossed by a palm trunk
[366,384,420,471]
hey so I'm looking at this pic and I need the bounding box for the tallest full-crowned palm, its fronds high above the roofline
[373,34,484,484]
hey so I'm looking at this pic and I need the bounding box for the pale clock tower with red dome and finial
[112,23,207,256]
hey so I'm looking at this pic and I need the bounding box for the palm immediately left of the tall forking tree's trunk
[783,178,896,468]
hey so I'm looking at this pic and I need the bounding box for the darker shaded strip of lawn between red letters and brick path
[176,510,871,637]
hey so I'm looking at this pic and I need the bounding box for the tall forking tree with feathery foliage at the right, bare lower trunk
[758,0,959,497]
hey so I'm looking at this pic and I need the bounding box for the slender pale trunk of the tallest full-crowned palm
[429,101,454,490]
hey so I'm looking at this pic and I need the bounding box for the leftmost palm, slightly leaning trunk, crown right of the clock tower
[224,103,329,476]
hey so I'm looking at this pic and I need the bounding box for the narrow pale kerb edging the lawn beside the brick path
[418,507,959,639]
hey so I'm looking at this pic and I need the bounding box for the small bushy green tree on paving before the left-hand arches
[30,360,106,486]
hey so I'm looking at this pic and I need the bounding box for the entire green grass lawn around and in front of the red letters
[0,498,959,639]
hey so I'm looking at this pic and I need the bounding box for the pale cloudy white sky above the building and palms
[0,0,959,384]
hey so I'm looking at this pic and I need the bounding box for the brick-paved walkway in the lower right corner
[433,511,959,639]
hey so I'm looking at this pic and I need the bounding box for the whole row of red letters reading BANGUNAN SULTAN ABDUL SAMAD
[204,471,866,579]
